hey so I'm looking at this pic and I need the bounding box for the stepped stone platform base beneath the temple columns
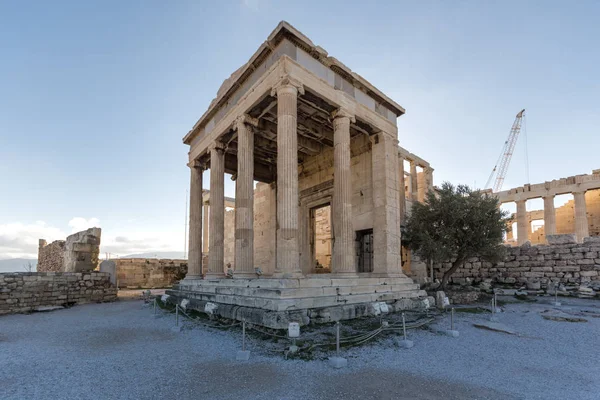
[166,275,434,329]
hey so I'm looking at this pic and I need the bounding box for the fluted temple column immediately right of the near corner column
[332,109,357,276]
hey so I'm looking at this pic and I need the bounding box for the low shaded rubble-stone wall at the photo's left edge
[0,272,117,315]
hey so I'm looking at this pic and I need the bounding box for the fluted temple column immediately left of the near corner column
[234,116,256,278]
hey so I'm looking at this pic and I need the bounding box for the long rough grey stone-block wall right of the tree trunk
[434,237,600,288]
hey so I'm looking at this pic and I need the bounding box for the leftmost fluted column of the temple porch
[185,162,204,279]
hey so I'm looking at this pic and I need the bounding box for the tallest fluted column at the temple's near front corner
[271,77,304,278]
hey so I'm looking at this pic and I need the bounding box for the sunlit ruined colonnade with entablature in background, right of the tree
[495,170,600,245]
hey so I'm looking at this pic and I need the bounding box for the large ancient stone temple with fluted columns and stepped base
[167,22,433,328]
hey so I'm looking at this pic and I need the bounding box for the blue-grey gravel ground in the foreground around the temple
[0,299,600,399]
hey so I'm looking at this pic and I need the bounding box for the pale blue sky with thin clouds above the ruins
[0,0,600,259]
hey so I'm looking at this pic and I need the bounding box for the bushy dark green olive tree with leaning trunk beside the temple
[402,182,508,286]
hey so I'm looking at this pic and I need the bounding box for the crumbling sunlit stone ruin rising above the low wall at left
[37,228,102,272]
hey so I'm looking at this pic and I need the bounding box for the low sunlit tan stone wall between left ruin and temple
[111,258,187,289]
